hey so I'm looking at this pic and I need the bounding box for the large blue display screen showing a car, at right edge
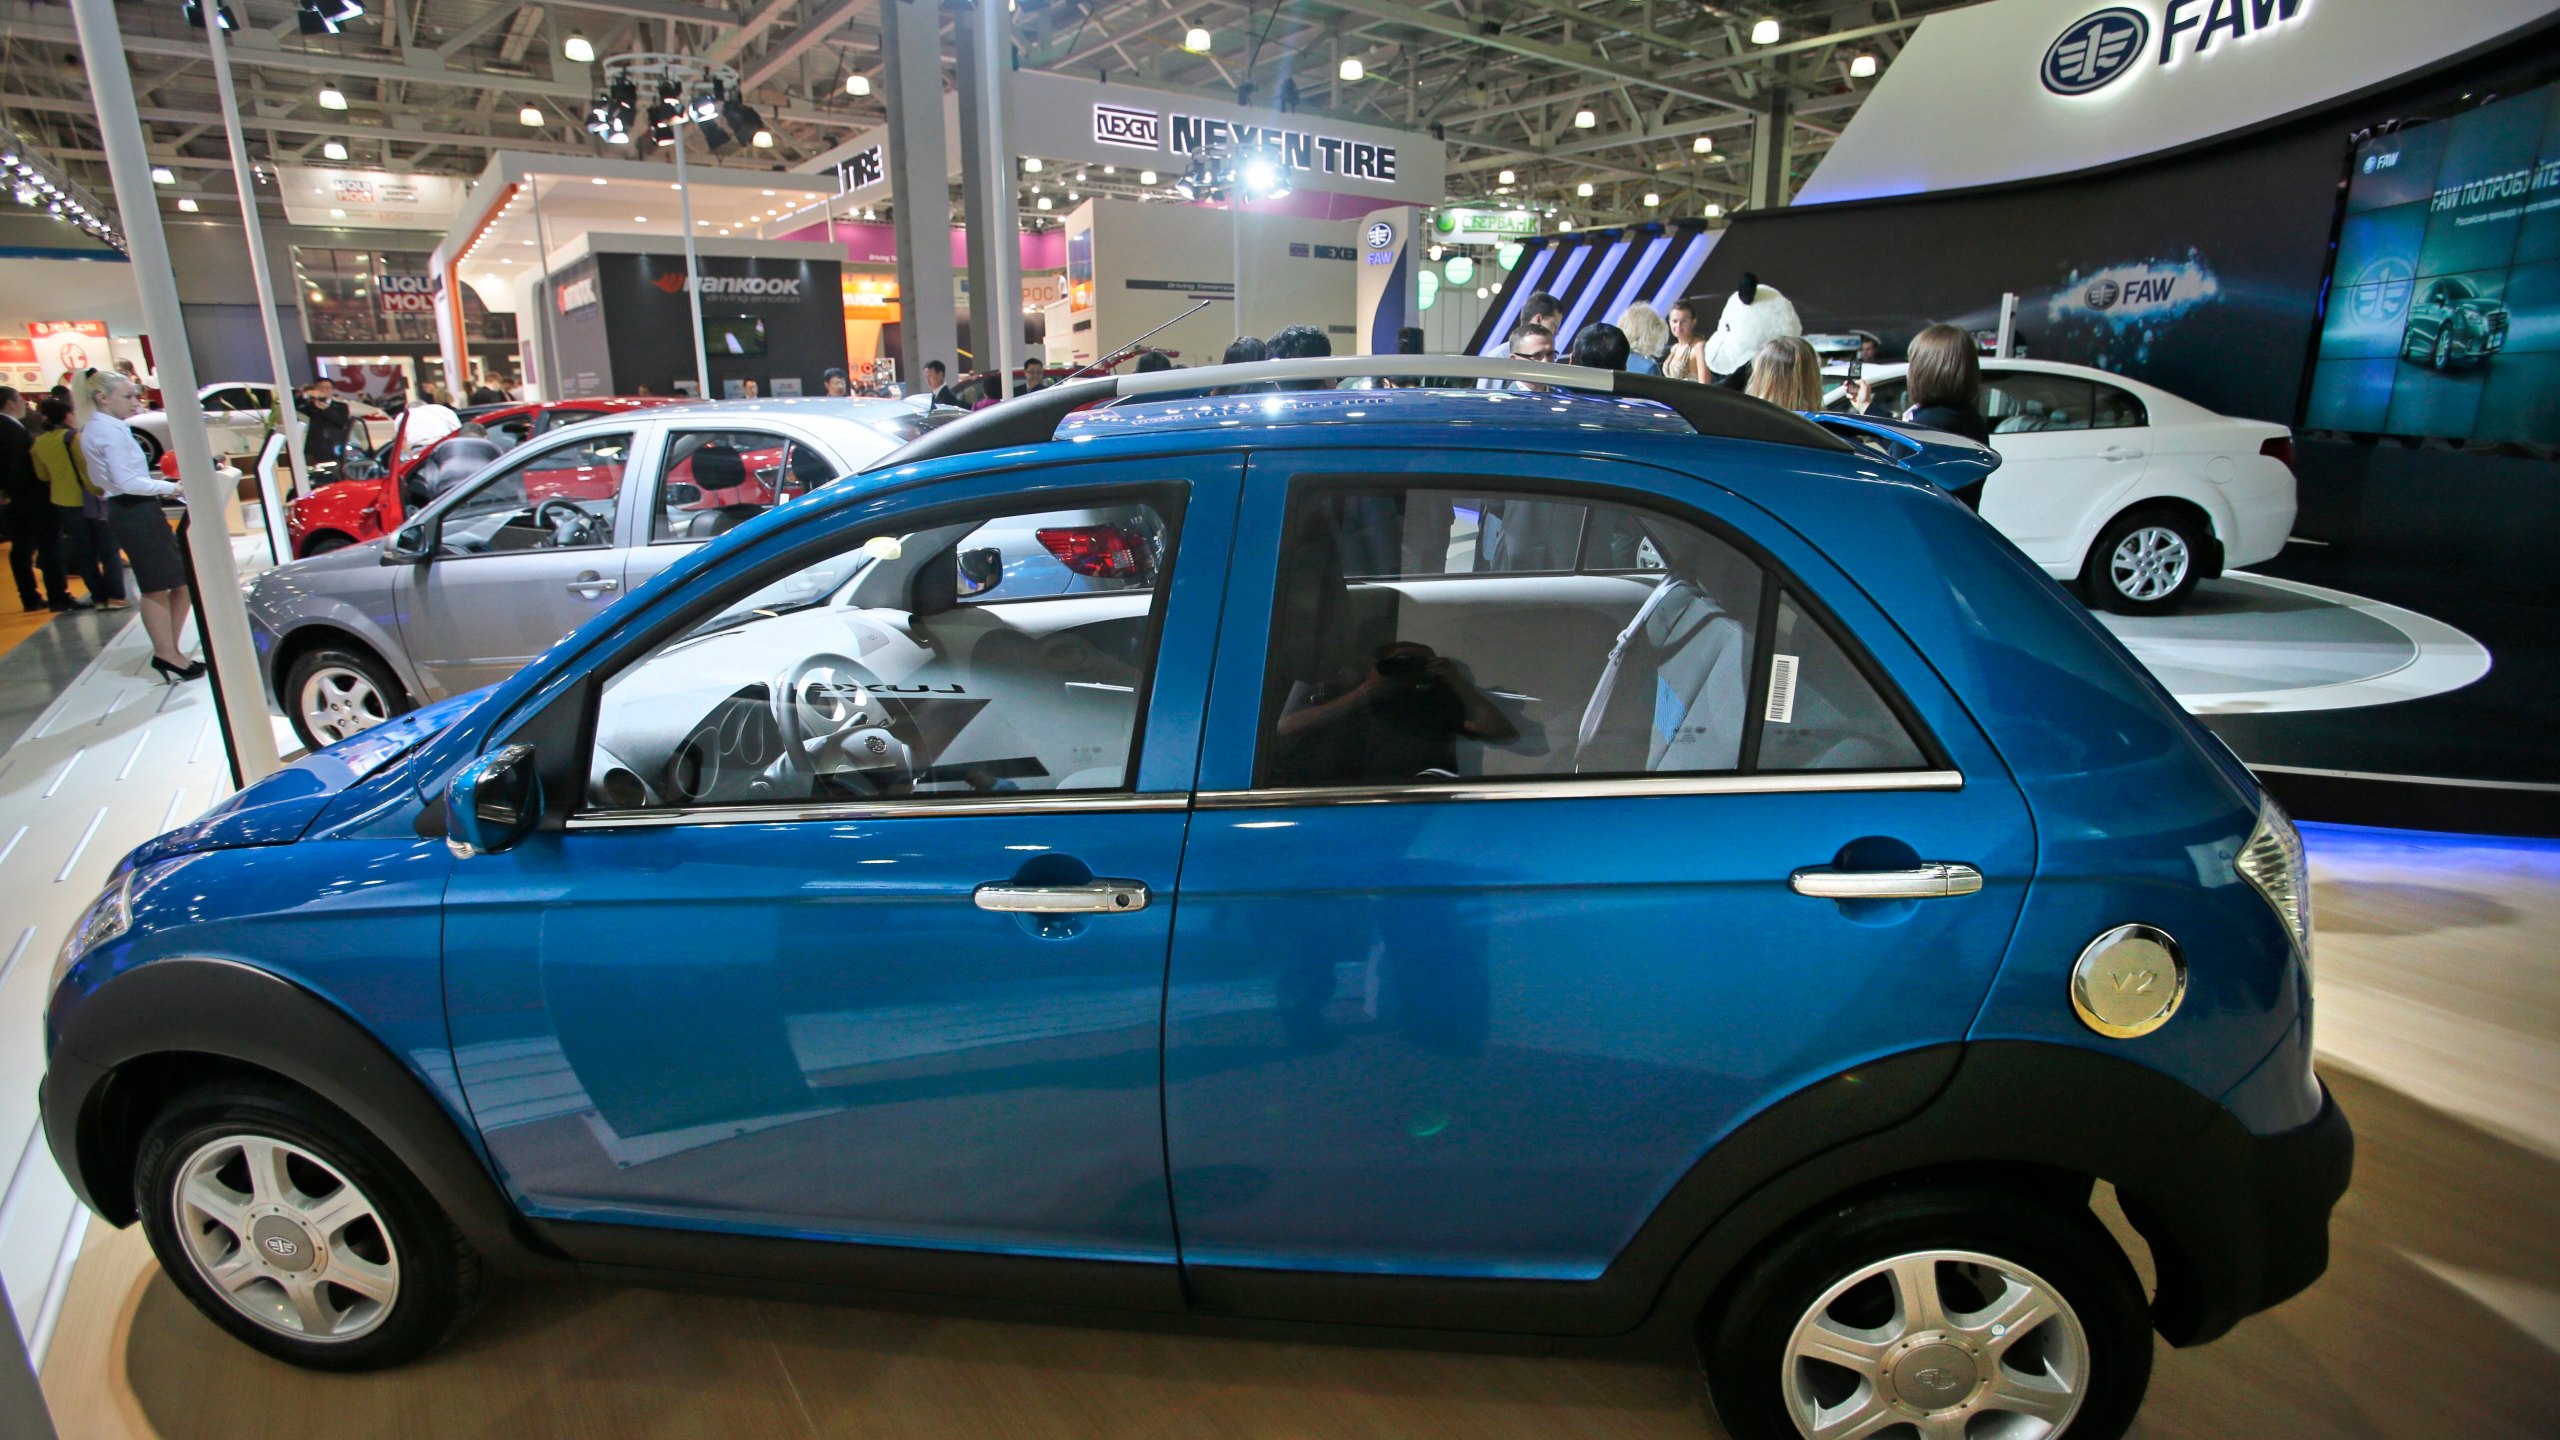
[2304,85,2560,446]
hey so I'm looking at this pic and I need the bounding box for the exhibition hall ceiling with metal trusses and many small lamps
[0,0,1953,235]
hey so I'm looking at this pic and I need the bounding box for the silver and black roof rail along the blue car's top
[868,356,1851,469]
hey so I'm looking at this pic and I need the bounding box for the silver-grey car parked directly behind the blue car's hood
[248,400,927,748]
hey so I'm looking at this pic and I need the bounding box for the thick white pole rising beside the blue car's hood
[72,0,276,787]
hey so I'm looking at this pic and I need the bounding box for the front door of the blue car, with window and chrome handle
[445,461,1242,1270]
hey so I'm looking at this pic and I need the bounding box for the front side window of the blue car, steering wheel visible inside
[586,487,1180,812]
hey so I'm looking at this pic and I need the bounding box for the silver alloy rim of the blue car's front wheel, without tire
[172,1135,399,1343]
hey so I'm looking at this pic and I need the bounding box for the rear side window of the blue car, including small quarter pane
[1257,482,1920,789]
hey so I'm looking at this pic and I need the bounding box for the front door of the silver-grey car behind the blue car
[394,425,650,697]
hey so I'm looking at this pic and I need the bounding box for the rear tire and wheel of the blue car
[1700,1189,2150,1440]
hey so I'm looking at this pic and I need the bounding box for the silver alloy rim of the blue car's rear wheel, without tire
[1782,1250,2089,1440]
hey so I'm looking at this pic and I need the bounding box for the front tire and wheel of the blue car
[133,1081,484,1371]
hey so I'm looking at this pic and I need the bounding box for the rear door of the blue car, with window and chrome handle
[1165,451,2033,1330]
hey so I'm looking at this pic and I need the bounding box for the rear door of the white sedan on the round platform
[1981,366,2148,569]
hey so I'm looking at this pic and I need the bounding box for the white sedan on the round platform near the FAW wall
[1830,359,2294,615]
